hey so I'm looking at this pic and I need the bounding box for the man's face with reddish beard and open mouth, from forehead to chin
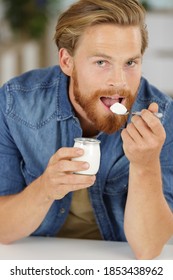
[67,24,142,134]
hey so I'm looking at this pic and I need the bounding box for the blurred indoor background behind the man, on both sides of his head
[0,0,173,97]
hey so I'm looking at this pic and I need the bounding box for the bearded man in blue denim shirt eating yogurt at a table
[0,0,173,259]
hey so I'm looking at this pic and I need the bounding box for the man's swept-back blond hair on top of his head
[54,0,148,55]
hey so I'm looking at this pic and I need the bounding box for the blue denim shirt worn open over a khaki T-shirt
[0,66,173,241]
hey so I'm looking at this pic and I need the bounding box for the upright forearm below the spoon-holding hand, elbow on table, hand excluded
[124,161,173,258]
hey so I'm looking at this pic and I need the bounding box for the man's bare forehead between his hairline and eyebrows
[76,24,142,58]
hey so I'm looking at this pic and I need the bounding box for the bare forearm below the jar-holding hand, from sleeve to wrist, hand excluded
[0,178,53,243]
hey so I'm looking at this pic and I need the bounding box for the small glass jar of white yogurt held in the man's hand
[73,137,100,175]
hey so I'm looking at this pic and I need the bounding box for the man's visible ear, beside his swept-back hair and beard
[59,48,74,76]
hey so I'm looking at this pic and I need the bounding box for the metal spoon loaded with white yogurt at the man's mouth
[110,102,163,119]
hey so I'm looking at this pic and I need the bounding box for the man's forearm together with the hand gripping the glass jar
[0,148,96,243]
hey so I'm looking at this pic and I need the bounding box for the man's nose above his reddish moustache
[107,68,126,89]
